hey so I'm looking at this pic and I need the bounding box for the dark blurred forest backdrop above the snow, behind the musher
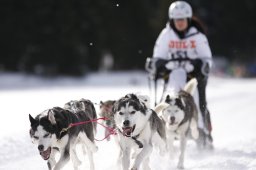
[0,0,256,77]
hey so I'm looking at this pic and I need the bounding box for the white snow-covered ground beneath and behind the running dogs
[0,72,256,170]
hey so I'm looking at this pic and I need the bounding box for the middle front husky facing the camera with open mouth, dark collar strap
[113,94,166,170]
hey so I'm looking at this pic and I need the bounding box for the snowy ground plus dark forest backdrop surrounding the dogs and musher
[0,0,256,170]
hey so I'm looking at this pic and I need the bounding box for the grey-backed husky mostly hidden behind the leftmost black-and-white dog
[64,98,97,135]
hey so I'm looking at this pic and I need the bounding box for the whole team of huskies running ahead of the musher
[29,79,206,170]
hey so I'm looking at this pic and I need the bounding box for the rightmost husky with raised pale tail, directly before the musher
[155,79,199,169]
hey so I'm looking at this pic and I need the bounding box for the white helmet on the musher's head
[169,1,192,19]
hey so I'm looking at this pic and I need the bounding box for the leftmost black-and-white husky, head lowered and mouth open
[29,107,98,170]
